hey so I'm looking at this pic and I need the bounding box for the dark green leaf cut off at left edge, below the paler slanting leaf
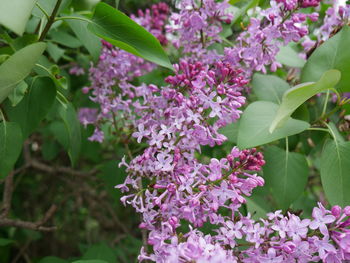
[0,122,22,179]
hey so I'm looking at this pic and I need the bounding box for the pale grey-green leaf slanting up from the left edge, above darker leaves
[0,43,46,103]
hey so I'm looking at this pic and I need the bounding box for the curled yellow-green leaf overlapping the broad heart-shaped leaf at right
[269,70,340,133]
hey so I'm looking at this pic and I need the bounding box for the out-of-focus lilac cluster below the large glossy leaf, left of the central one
[83,41,155,142]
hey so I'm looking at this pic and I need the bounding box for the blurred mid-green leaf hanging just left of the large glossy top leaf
[66,14,101,61]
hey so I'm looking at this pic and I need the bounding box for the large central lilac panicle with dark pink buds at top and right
[117,61,265,262]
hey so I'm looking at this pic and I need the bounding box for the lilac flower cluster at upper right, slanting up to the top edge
[225,0,319,76]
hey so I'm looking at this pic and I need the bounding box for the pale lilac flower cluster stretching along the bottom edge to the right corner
[139,203,350,263]
